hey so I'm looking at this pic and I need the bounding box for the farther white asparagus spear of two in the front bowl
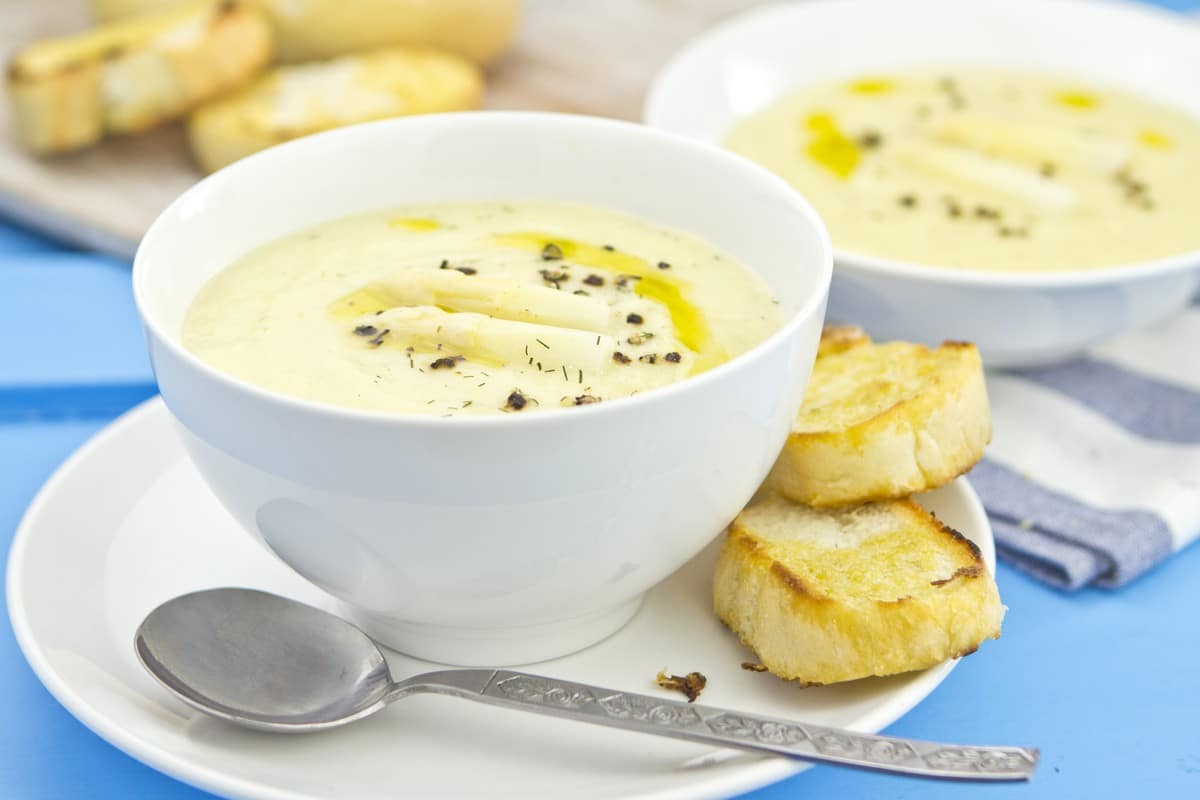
[371,270,610,332]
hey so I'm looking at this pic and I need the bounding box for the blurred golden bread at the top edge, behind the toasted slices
[92,0,521,64]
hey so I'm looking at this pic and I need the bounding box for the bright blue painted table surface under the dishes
[7,6,1200,800]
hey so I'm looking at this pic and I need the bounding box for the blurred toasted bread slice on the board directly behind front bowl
[187,47,484,172]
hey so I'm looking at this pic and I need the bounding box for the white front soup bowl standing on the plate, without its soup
[133,113,832,664]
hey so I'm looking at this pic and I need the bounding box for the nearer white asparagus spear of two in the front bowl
[358,306,617,372]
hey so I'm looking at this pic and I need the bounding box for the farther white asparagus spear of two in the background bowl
[930,114,1133,175]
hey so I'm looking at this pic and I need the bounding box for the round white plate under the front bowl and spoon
[8,399,994,800]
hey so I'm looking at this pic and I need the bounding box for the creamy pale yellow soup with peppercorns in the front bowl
[182,203,782,416]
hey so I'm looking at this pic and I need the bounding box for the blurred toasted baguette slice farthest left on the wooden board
[8,0,271,154]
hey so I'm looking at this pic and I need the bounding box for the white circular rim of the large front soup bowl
[132,110,833,429]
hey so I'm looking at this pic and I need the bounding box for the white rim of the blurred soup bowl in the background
[642,0,1200,289]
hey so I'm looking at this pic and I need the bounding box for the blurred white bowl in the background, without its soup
[643,0,1200,366]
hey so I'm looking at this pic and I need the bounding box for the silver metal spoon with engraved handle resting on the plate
[134,589,1038,781]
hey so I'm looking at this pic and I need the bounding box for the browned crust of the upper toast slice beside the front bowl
[767,335,991,507]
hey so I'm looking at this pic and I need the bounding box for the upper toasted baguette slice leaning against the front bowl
[767,327,991,507]
